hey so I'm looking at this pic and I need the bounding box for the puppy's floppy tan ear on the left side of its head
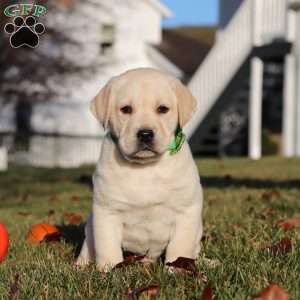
[90,80,113,130]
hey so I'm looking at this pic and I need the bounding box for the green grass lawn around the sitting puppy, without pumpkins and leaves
[0,158,300,300]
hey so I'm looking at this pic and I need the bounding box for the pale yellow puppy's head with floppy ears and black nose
[91,69,196,163]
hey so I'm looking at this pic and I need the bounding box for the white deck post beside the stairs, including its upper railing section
[249,0,264,159]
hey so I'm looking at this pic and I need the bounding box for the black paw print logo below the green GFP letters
[4,16,45,48]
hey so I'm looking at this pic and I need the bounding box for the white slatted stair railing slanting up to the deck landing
[185,0,287,137]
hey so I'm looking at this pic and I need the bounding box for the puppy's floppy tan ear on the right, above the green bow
[172,79,197,128]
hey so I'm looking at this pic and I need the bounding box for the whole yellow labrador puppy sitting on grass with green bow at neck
[77,68,202,271]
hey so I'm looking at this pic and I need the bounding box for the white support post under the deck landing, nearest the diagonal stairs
[249,57,264,159]
